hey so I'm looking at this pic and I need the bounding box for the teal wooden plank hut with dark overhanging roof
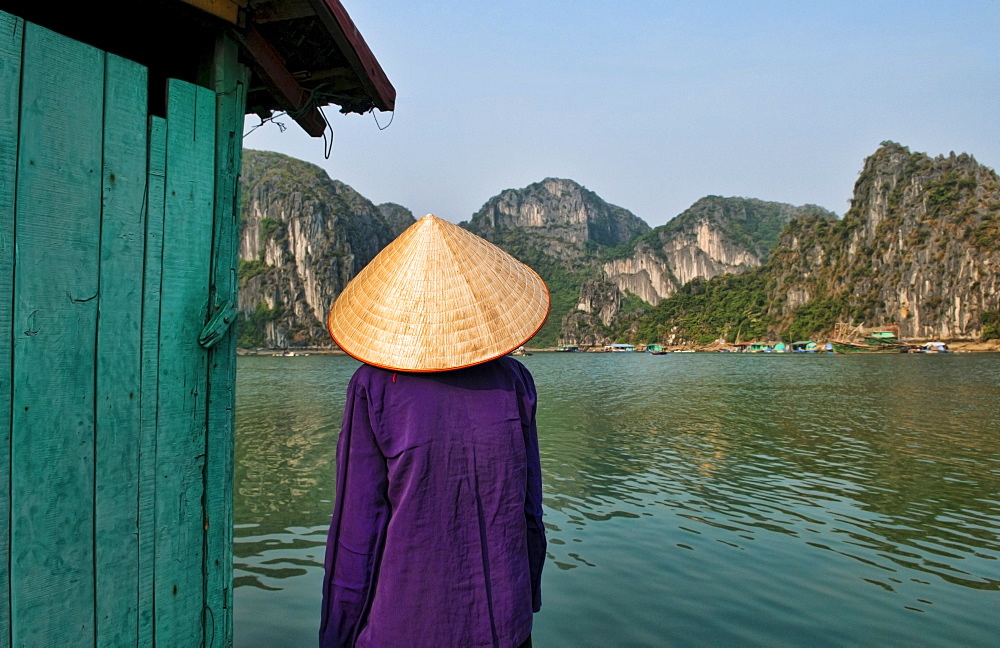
[0,0,395,647]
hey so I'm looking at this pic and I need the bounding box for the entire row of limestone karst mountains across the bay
[240,142,1000,347]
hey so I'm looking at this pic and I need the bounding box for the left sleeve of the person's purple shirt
[319,374,389,648]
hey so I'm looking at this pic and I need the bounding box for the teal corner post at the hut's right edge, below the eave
[205,37,246,646]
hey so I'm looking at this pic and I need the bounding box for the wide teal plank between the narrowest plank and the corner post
[154,80,215,646]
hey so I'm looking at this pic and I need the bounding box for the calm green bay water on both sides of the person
[235,353,1000,648]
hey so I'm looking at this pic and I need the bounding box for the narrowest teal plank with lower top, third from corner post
[137,117,167,646]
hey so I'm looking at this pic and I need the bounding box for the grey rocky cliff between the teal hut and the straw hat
[239,150,413,348]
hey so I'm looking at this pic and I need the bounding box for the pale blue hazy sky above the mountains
[244,0,1000,226]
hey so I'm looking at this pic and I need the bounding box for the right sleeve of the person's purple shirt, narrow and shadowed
[521,369,546,612]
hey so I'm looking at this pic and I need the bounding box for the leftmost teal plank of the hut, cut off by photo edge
[0,11,24,646]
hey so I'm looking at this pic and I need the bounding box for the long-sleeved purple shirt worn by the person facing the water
[320,357,545,648]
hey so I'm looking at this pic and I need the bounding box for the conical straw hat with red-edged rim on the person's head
[327,214,549,371]
